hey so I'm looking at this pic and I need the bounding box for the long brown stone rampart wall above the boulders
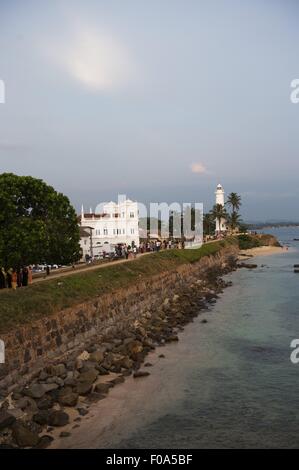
[0,247,237,389]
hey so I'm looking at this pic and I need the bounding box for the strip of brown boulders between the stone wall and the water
[0,256,237,448]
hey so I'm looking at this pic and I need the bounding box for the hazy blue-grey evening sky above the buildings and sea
[0,0,299,220]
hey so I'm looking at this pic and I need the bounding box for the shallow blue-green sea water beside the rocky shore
[106,228,299,448]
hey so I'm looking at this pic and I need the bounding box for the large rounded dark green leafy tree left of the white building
[0,173,80,268]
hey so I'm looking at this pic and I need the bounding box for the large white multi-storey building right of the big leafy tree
[79,199,139,256]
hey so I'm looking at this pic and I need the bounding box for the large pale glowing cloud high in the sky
[48,26,135,92]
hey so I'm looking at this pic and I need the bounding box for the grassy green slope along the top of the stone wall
[0,239,237,332]
